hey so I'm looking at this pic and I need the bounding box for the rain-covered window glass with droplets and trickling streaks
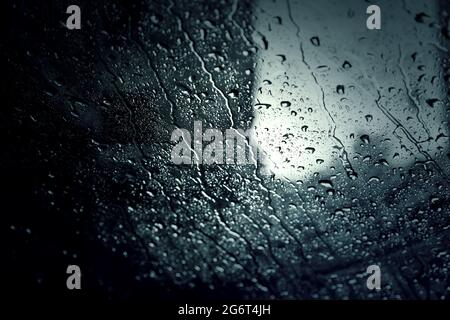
[0,0,450,299]
